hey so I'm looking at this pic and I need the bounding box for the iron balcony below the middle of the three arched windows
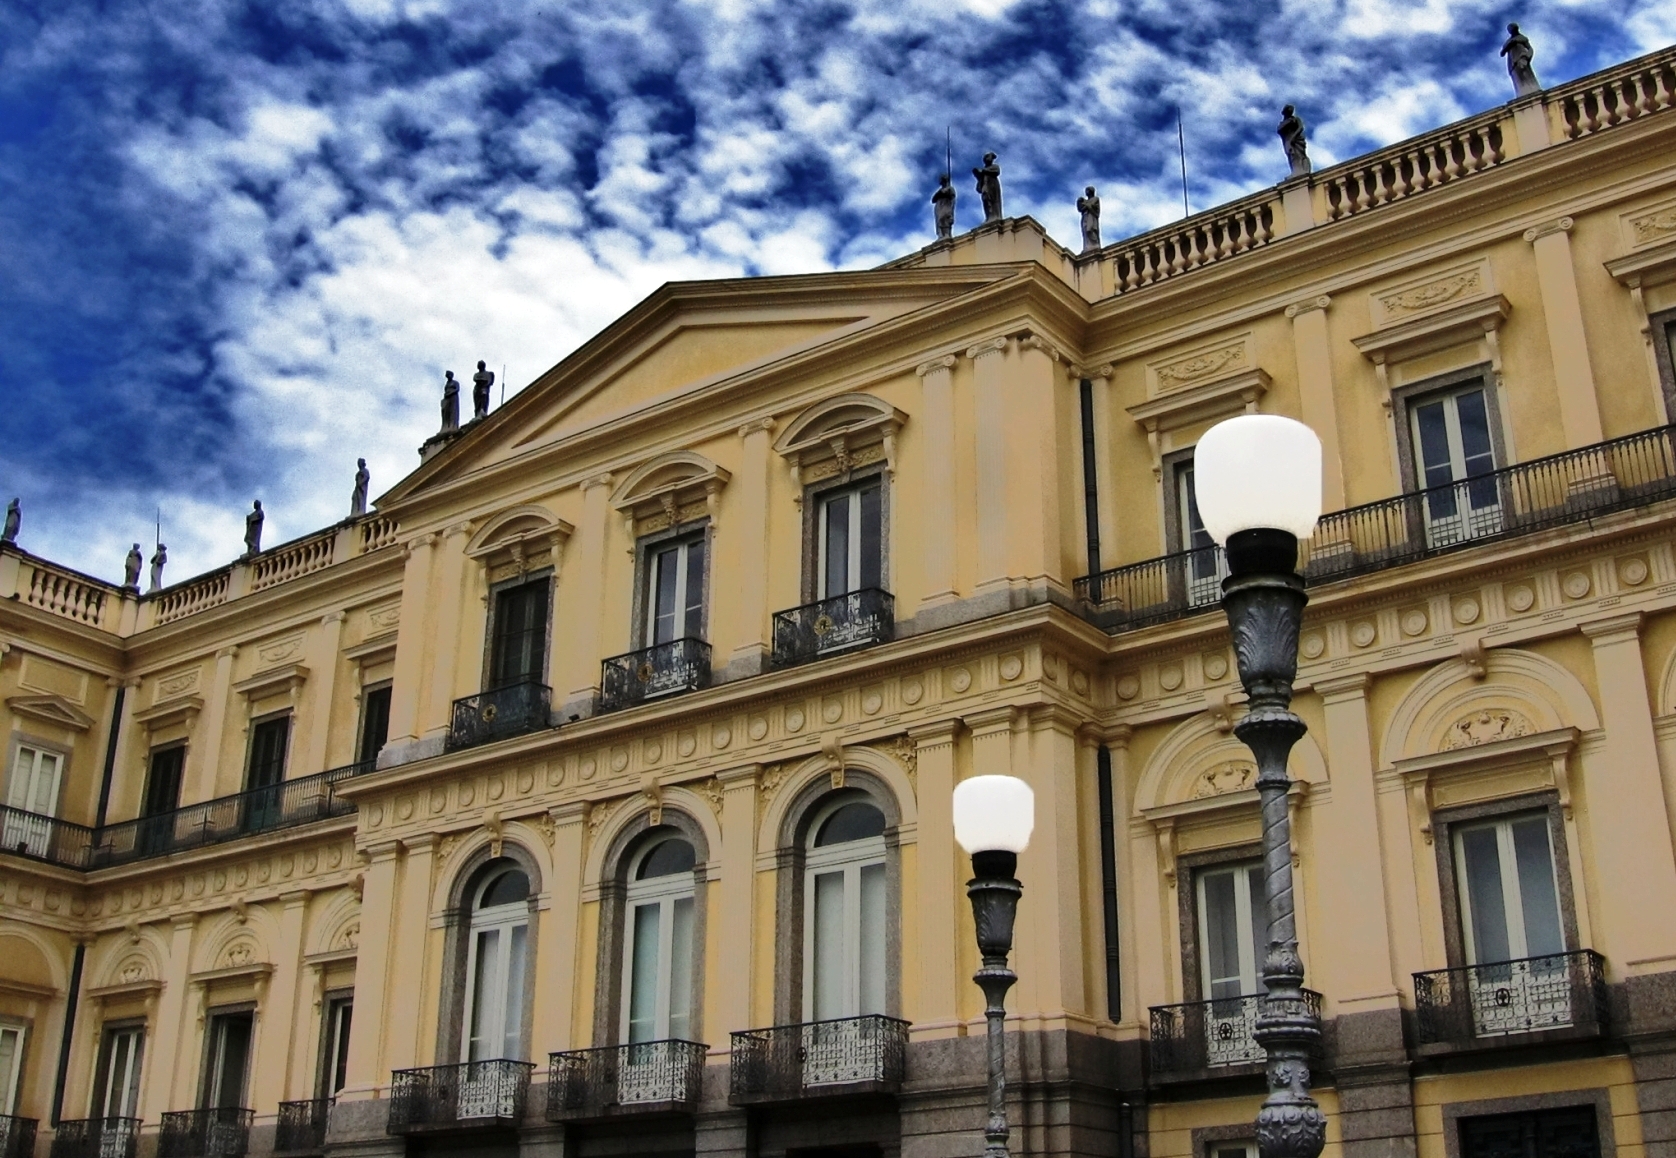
[546,1041,711,1121]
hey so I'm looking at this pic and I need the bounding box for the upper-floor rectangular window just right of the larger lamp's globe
[1408,382,1502,546]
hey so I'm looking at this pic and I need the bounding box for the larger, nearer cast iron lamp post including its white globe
[1193,414,1327,1158]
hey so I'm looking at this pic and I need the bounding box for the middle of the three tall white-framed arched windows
[620,835,697,1044]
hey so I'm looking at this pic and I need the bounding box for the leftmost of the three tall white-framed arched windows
[459,861,530,1061]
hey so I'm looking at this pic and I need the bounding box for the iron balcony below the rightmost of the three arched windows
[727,1014,908,1106]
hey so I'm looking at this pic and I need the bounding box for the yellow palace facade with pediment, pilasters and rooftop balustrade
[0,52,1676,1158]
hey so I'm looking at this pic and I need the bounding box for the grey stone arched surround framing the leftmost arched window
[436,841,543,1064]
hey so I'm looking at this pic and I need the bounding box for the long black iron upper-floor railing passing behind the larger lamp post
[1074,426,1676,630]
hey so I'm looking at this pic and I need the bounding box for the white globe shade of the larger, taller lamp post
[1193,414,1321,546]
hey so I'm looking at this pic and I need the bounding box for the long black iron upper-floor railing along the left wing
[0,761,374,868]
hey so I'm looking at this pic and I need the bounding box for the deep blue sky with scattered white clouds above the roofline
[0,0,1676,580]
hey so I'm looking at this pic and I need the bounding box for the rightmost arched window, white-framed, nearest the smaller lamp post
[803,793,888,1021]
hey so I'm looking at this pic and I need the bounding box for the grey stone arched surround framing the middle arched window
[593,807,712,1046]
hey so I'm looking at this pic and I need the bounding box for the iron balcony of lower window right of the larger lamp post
[1415,949,1607,1054]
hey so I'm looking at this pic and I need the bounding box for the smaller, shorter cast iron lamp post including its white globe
[954,776,1036,1158]
